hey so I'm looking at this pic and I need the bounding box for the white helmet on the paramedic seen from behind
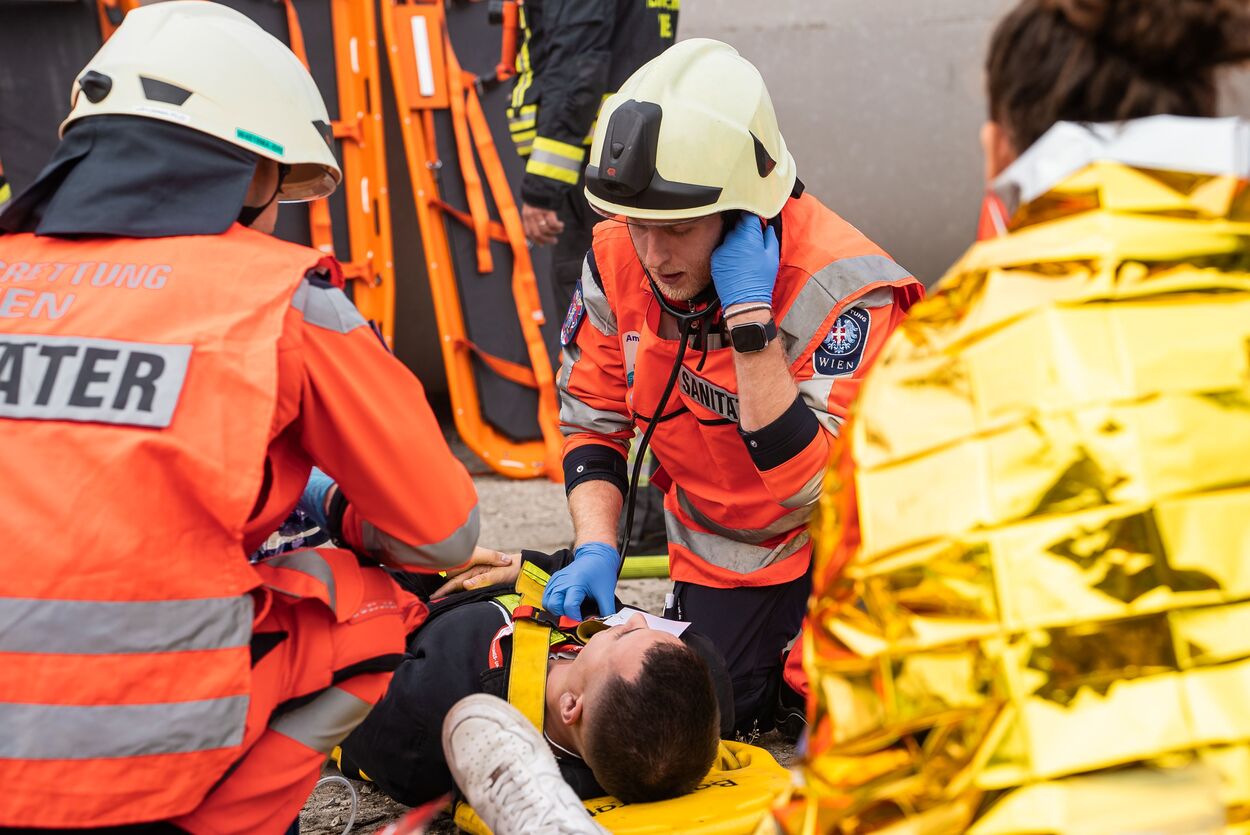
[61,0,343,203]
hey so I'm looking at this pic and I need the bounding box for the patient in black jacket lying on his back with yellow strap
[340,549,733,816]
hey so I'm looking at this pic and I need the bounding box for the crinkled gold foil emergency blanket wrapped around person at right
[779,125,1250,834]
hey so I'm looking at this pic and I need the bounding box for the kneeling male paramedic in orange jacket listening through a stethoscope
[544,39,921,733]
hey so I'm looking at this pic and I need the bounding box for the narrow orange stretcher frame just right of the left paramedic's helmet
[284,0,395,346]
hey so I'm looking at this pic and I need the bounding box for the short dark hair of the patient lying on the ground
[583,644,720,803]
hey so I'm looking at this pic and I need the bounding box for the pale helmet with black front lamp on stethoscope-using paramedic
[586,38,795,223]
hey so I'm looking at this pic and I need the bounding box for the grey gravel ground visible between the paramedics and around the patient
[300,472,794,835]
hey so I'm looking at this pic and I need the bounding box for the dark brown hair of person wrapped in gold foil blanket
[986,0,1250,151]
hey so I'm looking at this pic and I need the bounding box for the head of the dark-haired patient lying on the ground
[549,615,720,803]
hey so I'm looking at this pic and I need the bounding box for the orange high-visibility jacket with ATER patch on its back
[0,226,478,828]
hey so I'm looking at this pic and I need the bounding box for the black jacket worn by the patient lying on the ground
[341,550,734,806]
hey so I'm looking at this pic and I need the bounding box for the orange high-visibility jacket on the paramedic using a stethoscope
[559,195,923,588]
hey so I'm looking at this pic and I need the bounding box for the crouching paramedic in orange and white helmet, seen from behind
[0,0,478,834]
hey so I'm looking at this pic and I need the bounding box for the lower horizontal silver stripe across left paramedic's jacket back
[0,695,248,760]
